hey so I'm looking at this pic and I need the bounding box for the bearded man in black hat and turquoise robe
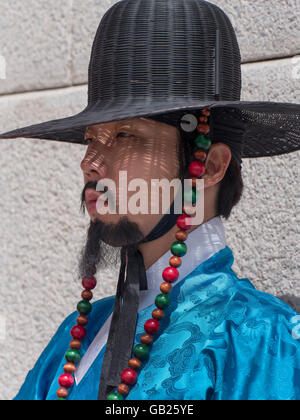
[0,0,300,400]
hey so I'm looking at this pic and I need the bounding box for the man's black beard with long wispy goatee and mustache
[79,182,145,278]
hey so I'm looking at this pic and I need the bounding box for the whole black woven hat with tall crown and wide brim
[0,0,300,162]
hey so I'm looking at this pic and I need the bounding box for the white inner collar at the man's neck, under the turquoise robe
[75,216,226,385]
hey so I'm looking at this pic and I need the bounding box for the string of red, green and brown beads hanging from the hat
[56,109,211,400]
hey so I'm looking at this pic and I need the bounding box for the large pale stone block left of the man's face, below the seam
[0,83,118,400]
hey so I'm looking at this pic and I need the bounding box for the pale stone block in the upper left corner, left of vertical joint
[0,0,72,94]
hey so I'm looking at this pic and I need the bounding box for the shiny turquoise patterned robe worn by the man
[16,246,300,400]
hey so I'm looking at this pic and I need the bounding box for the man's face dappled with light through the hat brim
[81,118,179,240]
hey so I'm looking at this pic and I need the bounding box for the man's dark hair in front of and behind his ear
[179,131,244,219]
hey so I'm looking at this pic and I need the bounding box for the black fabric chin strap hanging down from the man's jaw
[98,172,188,400]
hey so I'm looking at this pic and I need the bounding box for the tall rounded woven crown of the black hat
[88,0,241,108]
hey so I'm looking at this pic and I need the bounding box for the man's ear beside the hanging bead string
[202,143,231,188]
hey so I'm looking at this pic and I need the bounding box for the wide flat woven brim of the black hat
[0,98,300,158]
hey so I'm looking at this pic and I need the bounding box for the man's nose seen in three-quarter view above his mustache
[80,150,107,181]
